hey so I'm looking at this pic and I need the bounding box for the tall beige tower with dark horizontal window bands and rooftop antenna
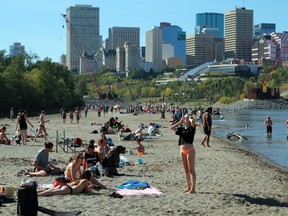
[225,8,253,61]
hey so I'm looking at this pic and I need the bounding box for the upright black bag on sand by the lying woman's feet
[17,186,38,216]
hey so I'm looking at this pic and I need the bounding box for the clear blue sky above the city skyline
[0,0,288,62]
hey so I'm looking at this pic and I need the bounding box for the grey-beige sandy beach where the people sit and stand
[0,111,288,216]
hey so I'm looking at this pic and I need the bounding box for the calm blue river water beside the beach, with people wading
[212,109,288,169]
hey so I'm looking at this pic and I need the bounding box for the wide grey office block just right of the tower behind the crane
[108,27,140,50]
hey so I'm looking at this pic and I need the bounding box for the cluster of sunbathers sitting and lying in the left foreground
[23,139,109,196]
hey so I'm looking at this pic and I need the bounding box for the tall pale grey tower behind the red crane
[66,4,102,72]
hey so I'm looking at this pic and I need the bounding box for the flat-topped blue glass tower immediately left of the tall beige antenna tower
[195,13,224,38]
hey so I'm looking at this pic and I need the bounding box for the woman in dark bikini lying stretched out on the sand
[37,170,93,196]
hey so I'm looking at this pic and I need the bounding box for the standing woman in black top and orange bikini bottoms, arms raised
[171,115,196,193]
